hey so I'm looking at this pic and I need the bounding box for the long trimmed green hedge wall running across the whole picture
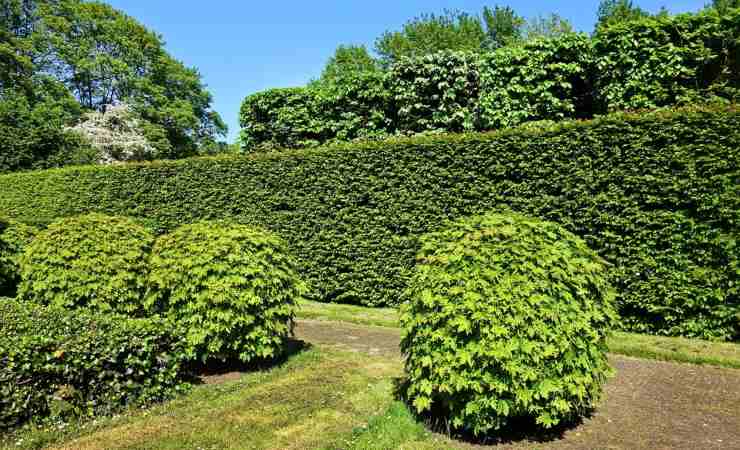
[0,108,740,340]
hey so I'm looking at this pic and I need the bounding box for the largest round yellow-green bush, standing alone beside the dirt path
[401,214,616,436]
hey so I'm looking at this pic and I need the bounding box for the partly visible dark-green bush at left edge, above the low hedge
[0,218,38,297]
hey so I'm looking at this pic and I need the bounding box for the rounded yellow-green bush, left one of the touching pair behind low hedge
[18,214,154,315]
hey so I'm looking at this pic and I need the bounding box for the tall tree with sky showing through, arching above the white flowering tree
[35,0,226,158]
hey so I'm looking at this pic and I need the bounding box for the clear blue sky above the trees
[107,0,709,142]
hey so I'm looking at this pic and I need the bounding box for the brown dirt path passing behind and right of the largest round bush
[296,320,740,450]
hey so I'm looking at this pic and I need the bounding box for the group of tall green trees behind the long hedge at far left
[0,0,226,172]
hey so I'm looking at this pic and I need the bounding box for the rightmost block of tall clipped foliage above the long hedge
[594,9,740,111]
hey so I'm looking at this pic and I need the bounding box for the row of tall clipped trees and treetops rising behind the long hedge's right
[240,0,740,151]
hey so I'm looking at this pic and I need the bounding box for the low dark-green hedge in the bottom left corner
[0,299,187,429]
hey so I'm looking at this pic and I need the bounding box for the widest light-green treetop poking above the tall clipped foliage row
[375,10,486,65]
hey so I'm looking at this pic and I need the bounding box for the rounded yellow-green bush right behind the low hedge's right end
[146,222,305,362]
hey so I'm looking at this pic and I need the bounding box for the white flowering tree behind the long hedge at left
[69,103,157,164]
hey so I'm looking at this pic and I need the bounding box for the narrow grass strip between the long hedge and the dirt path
[298,302,740,369]
